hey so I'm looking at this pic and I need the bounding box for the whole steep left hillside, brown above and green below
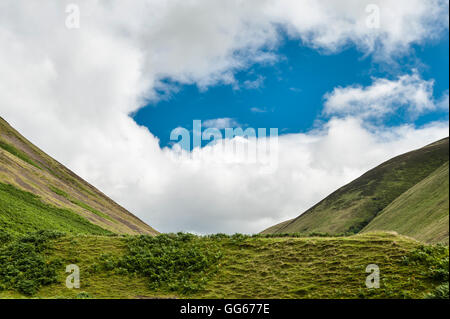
[0,117,158,235]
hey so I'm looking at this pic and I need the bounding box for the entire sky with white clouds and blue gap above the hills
[0,0,449,233]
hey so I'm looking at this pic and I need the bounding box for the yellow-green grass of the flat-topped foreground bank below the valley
[0,233,448,299]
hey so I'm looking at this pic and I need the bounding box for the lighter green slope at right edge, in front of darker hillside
[362,162,449,244]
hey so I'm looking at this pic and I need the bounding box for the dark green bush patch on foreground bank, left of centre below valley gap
[101,233,222,294]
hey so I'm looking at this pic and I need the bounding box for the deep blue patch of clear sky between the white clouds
[133,34,449,147]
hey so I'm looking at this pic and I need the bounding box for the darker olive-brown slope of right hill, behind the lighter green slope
[263,138,449,242]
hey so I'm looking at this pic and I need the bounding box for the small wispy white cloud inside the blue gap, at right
[324,72,443,118]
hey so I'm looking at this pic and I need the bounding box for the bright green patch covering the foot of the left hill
[0,183,111,235]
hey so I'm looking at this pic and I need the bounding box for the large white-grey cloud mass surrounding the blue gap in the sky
[0,0,448,233]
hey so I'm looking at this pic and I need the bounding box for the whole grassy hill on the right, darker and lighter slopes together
[263,138,449,242]
